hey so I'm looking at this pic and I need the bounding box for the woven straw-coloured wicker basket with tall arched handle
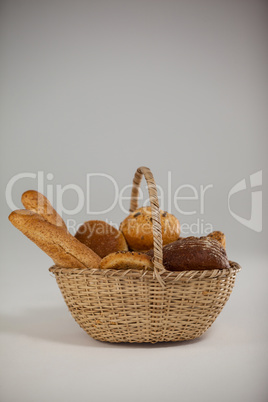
[50,167,241,343]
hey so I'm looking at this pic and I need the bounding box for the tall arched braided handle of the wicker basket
[129,166,166,287]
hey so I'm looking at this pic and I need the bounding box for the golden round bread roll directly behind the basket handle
[120,207,180,252]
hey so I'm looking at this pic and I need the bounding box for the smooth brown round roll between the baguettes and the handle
[75,220,128,258]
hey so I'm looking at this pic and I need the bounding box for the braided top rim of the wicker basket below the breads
[49,261,242,282]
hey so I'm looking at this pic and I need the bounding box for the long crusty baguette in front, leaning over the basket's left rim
[9,209,101,268]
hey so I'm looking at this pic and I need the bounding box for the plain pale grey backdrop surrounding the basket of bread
[0,0,268,401]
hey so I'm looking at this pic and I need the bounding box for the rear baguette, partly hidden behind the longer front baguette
[21,190,67,230]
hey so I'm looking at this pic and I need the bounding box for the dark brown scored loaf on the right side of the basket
[147,236,230,271]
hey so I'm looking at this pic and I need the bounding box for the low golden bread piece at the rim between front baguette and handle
[100,251,154,270]
